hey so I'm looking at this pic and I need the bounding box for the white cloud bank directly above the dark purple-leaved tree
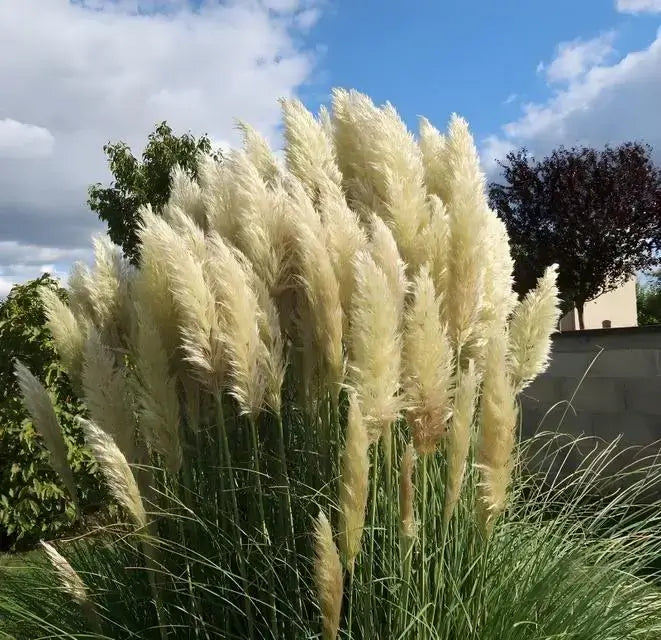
[482,30,661,171]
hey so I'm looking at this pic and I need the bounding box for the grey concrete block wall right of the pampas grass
[522,326,661,472]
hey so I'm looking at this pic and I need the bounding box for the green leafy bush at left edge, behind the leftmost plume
[0,274,104,549]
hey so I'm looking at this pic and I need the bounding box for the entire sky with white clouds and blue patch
[0,0,661,297]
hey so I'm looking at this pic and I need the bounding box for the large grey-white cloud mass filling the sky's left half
[0,0,320,296]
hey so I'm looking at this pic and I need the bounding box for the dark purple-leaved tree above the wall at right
[489,142,661,328]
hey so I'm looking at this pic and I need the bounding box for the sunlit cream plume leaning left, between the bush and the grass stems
[78,418,147,528]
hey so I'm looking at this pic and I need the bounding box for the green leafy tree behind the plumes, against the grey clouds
[87,122,221,263]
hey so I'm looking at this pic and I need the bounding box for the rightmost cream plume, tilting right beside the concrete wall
[509,265,560,392]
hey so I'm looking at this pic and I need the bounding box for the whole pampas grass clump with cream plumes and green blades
[0,91,661,640]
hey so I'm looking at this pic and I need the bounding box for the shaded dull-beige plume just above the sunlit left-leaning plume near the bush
[83,328,135,461]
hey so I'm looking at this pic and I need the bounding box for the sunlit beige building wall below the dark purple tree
[560,277,638,331]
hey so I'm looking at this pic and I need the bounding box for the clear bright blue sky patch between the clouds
[303,0,661,144]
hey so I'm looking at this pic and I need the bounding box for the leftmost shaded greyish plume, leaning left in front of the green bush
[14,360,78,504]
